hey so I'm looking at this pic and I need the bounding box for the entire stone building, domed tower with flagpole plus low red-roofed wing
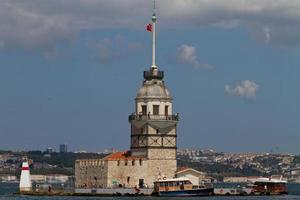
[75,2,179,188]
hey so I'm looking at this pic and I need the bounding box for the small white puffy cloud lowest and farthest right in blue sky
[224,80,259,99]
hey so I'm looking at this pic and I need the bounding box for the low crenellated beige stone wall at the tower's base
[75,159,177,188]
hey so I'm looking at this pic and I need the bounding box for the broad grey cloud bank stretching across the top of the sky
[0,0,300,51]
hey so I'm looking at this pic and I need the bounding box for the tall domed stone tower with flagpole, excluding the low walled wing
[129,3,178,181]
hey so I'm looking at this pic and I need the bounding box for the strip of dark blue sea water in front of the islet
[0,183,300,200]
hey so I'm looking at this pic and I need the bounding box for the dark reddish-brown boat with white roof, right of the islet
[251,176,288,195]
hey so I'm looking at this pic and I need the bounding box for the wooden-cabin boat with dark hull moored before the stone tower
[153,178,213,197]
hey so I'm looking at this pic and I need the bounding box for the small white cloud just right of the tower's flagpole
[177,44,212,69]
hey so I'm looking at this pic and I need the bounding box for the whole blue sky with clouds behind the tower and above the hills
[0,0,300,153]
